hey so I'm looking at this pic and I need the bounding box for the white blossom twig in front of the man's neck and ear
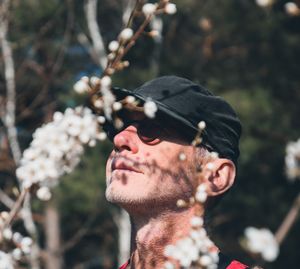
[164,121,219,269]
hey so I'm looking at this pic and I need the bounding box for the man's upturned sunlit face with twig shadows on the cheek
[106,117,199,210]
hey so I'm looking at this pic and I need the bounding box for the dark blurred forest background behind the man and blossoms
[0,0,300,269]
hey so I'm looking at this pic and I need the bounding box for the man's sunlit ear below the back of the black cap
[203,158,236,196]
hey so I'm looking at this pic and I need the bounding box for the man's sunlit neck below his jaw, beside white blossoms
[130,207,202,269]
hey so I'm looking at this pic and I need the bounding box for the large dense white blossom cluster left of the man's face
[16,107,105,200]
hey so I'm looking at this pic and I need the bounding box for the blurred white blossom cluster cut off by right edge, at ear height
[285,139,300,180]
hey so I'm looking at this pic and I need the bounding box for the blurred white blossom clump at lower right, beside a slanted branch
[245,227,279,262]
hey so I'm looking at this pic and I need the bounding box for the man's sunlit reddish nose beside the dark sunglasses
[113,125,139,153]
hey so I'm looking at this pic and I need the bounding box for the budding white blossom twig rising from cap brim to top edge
[74,0,177,121]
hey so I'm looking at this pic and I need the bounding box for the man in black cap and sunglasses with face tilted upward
[104,76,247,269]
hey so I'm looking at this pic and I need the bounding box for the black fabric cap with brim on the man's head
[113,76,241,162]
